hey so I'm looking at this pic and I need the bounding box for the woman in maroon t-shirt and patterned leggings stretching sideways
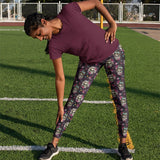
[24,0,133,160]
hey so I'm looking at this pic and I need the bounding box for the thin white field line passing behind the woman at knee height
[0,97,113,104]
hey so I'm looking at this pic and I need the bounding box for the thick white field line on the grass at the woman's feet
[0,145,135,153]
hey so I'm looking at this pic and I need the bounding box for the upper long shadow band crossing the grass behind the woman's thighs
[0,63,160,98]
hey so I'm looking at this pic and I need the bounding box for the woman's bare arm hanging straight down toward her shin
[53,58,65,123]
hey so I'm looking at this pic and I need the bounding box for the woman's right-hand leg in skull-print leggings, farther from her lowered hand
[104,47,128,143]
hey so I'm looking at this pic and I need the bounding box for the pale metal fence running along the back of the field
[0,2,160,23]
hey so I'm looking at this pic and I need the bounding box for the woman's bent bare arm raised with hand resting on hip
[77,0,117,43]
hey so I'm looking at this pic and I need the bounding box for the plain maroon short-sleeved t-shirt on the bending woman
[49,2,119,63]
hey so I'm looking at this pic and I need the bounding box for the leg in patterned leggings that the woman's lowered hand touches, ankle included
[52,62,102,146]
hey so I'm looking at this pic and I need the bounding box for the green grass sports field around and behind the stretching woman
[0,27,160,160]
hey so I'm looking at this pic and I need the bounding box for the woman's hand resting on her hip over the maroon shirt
[105,23,117,43]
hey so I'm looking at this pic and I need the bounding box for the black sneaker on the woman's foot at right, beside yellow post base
[118,143,133,160]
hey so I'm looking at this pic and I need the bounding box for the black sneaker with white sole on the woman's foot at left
[39,143,59,160]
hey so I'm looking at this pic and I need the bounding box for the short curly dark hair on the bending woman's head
[24,13,45,36]
